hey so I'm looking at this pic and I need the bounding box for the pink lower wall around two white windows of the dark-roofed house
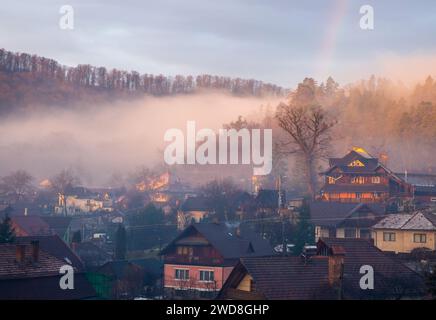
[164,264,233,291]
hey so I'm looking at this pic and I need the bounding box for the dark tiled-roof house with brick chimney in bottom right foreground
[218,238,426,300]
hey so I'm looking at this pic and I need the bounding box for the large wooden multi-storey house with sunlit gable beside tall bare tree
[321,148,413,203]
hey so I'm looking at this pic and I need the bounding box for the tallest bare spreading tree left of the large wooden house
[276,103,336,198]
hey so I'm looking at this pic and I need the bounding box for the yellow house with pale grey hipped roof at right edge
[372,211,436,253]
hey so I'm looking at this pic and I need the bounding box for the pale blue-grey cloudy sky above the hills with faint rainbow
[0,0,436,87]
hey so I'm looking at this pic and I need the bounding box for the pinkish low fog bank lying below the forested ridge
[0,93,279,186]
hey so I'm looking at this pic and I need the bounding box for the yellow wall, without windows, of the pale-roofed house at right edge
[373,229,436,253]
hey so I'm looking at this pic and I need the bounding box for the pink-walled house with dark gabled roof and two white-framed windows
[161,223,274,297]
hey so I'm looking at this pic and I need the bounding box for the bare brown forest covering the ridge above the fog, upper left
[0,49,286,112]
